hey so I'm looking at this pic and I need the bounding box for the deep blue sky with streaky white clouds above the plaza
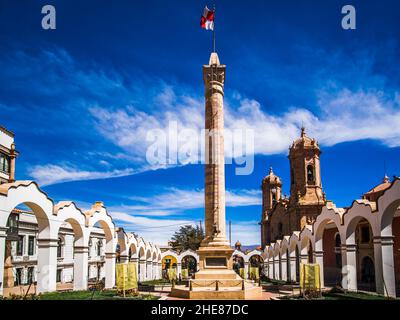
[0,0,400,244]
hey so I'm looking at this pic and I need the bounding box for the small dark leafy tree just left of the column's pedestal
[171,225,204,252]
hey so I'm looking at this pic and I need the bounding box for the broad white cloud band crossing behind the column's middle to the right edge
[92,87,400,169]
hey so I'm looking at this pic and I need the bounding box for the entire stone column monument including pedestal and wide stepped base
[171,52,262,299]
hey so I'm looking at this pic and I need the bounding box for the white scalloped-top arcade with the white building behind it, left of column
[0,127,161,295]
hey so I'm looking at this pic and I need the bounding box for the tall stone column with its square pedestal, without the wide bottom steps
[195,52,236,279]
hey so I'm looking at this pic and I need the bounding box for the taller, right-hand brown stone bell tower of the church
[289,128,326,230]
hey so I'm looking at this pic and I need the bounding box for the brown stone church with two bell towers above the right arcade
[261,128,327,248]
